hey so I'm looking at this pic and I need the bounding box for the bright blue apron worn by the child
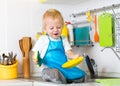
[43,37,85,80]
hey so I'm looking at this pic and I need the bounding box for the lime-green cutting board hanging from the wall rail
[98,13,114,47]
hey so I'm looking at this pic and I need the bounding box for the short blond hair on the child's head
[42,9,64,31]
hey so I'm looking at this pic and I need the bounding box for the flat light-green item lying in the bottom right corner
[96,79,120,86]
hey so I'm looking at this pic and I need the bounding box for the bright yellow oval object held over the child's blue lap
[62,56,83,68]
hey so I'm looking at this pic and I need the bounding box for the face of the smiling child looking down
[45,18,63,39]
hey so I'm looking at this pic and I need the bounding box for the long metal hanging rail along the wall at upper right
[71,4,120,17]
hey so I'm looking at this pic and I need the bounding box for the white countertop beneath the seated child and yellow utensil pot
[0,77,100,86]
